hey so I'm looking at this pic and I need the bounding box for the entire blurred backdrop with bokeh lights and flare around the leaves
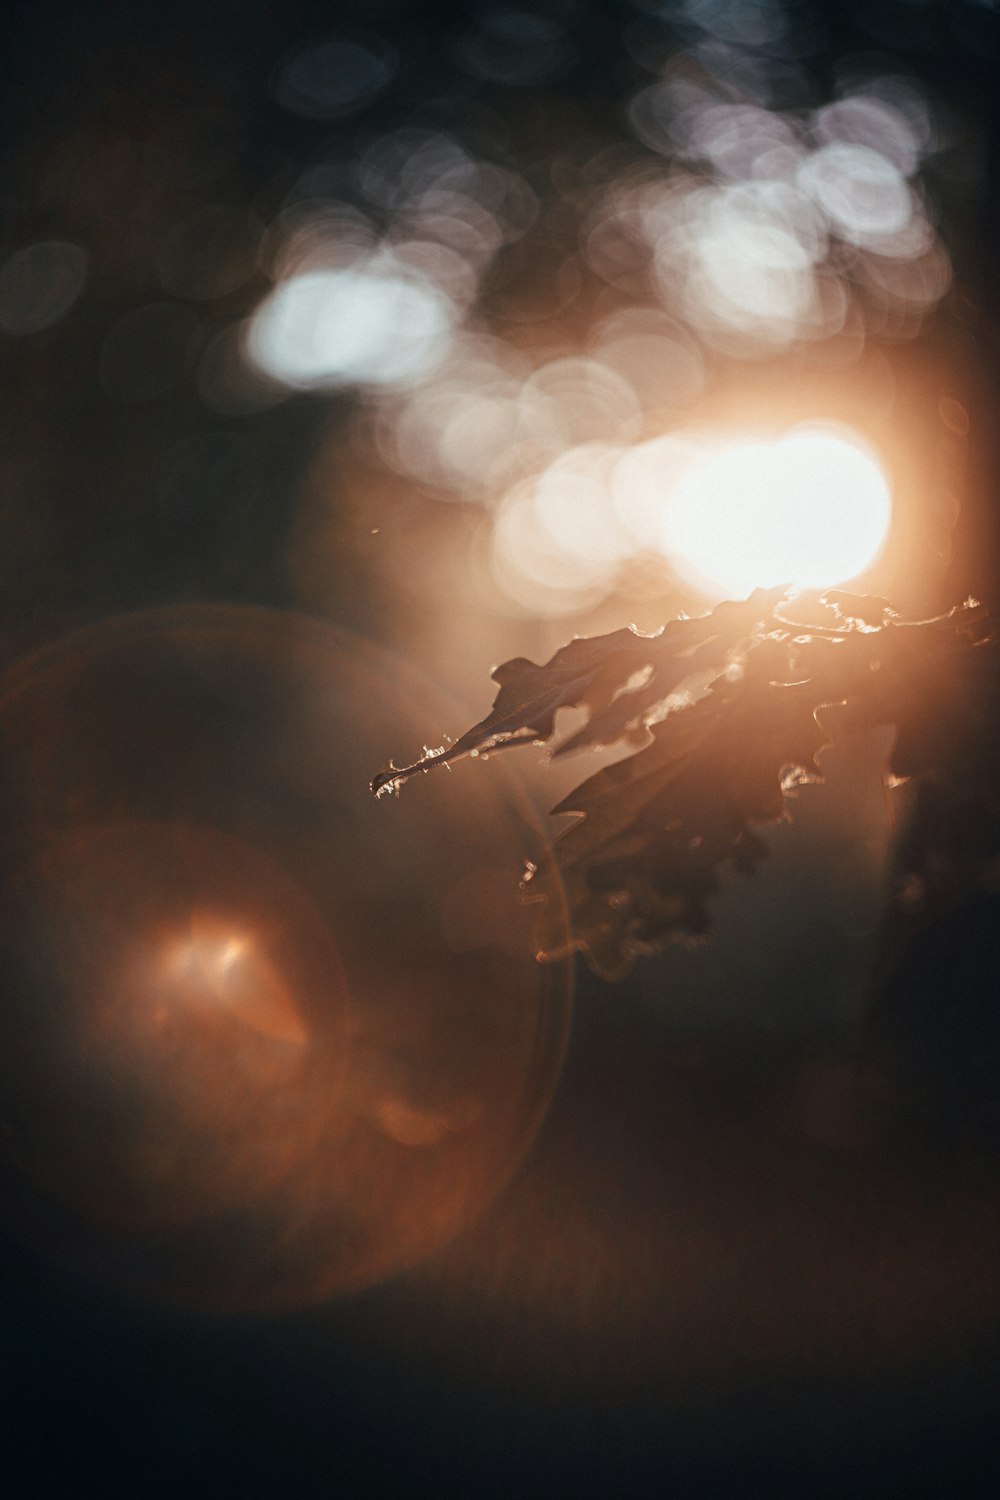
[0,0,1000,1496]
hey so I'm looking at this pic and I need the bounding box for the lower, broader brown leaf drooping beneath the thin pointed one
[525,681,828,978]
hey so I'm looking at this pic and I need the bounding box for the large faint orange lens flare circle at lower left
[0,606,570,1313]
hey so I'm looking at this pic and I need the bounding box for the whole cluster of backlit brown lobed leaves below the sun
[372,590,1000,978]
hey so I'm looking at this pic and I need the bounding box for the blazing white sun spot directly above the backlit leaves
[661,428,892,597]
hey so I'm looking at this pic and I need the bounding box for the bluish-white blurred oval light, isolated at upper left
[246,260,453,390]
